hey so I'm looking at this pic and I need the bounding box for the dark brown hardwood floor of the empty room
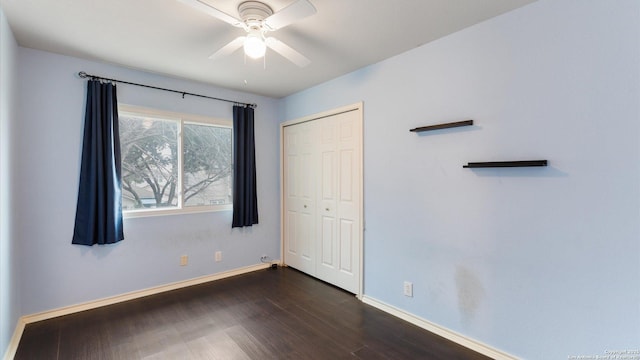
[15,268,488,360]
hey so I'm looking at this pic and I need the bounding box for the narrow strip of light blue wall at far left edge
[0,7,21,355]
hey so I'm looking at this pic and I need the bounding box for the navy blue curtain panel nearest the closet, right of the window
[231,105,258,228]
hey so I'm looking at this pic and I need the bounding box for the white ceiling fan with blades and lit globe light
[178,0,316,67]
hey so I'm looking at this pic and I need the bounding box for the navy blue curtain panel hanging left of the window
[72,80,124,246]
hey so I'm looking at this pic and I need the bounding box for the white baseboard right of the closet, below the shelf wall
[362,295,518,360]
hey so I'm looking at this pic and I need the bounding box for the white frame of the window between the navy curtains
[118,104,233,219]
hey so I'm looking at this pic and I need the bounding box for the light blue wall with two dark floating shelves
[283,0,640,359]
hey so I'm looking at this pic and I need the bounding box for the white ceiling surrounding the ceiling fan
[0,0,535,98]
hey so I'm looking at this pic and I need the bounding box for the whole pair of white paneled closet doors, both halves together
[282,103,362,294]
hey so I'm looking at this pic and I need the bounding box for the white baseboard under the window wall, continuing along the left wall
[4,263,271,360]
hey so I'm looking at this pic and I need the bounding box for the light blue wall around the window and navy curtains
[13,48,281,315]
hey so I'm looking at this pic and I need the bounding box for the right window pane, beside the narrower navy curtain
[183,123,232,206]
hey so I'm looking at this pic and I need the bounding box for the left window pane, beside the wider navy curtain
[119,115,179,210]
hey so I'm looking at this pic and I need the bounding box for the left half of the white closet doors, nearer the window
[283,123,316,274]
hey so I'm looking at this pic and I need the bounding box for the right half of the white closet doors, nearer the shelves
[316,112,361,292]
